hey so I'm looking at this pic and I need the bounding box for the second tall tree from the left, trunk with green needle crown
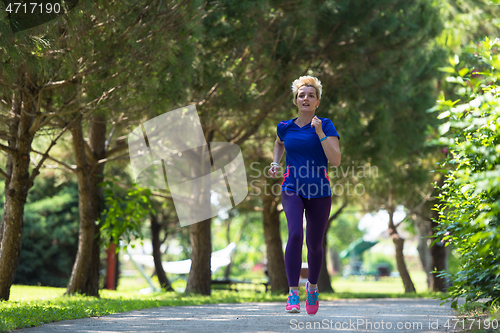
[62,1,193,295]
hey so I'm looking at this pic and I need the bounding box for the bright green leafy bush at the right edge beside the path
[435,38,500,306]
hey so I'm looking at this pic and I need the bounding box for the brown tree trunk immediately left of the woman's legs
[261,187,288,293]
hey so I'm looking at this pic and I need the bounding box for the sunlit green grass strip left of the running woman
[0,286,284,332]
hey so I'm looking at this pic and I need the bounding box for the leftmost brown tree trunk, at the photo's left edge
[0,81,37,301]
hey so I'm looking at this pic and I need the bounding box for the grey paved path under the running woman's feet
[15,298,455,333]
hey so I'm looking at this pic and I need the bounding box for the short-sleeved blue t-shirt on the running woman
[277,117,340,198]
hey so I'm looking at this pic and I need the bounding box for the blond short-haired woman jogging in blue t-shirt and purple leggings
[269,76,341,315]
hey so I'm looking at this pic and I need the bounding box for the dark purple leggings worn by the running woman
[281,191,332,287]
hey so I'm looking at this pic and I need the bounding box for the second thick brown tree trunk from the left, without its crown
[66,118,96,295]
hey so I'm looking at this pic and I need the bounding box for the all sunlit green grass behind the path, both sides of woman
[0,274,435,332]
